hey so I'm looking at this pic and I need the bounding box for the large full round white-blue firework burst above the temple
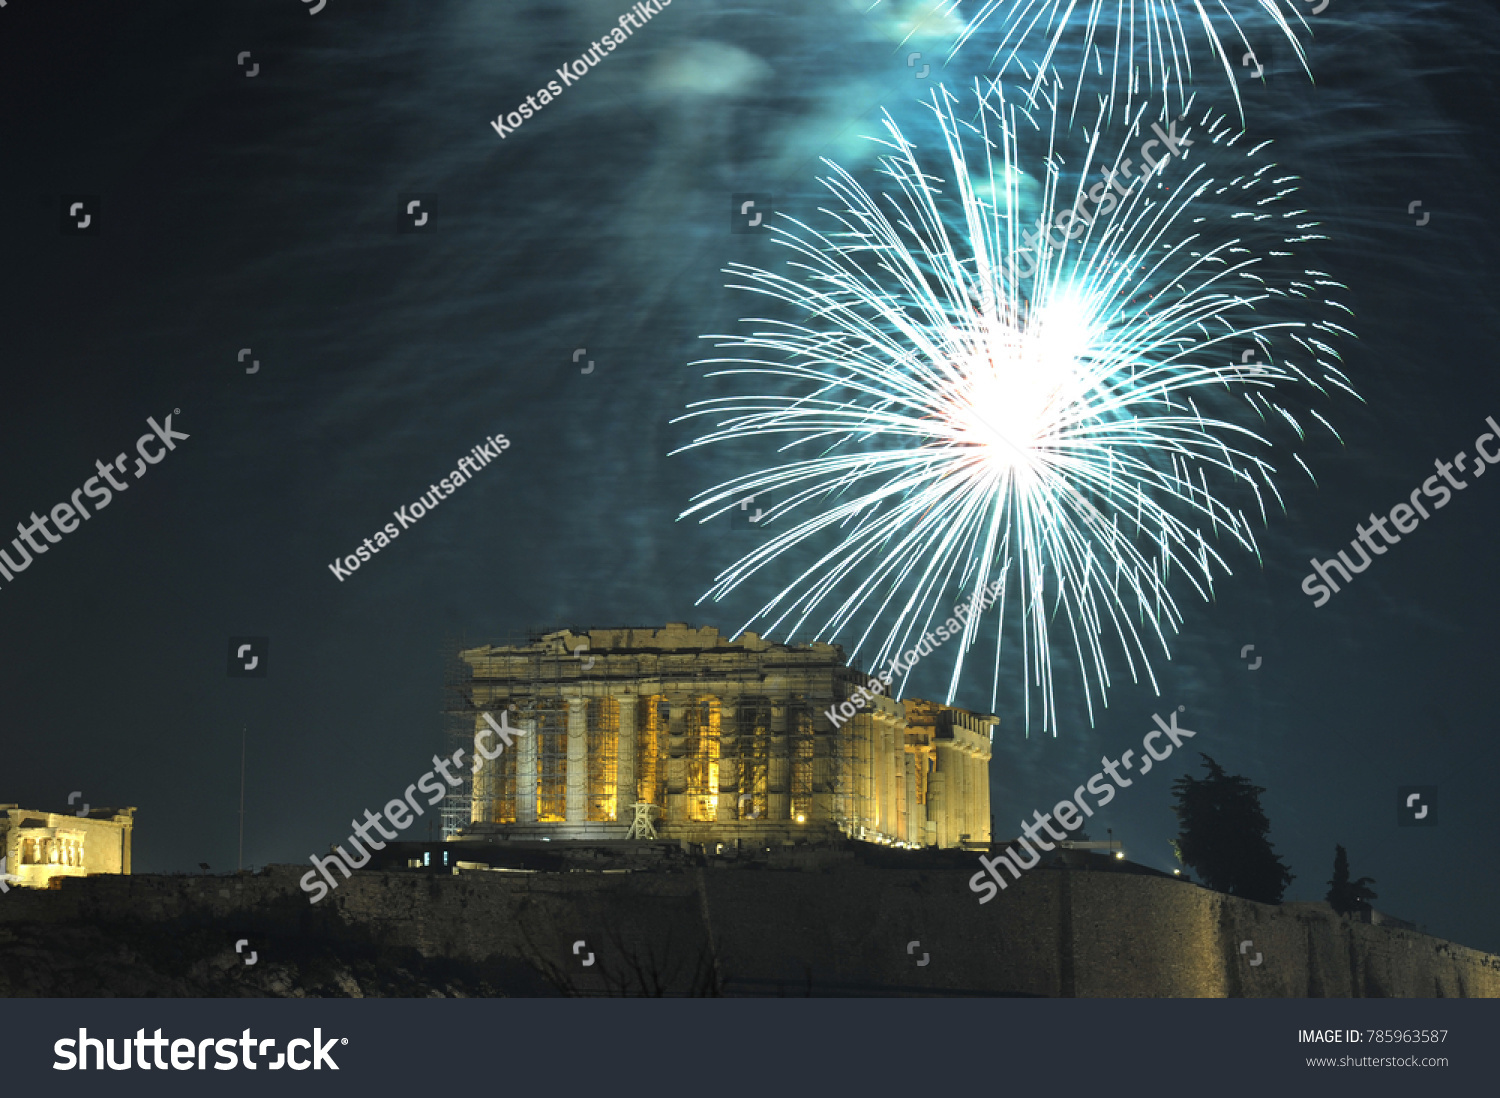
[677,81,1352,731]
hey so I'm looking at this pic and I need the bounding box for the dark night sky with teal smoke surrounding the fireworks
[0,0,1500,951]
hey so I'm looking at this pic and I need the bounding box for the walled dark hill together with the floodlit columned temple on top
[0,624,1500,998]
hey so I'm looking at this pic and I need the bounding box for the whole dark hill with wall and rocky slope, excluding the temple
[0,843,1500,998]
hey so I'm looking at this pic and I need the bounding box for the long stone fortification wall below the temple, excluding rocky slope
[0,852,1500,998]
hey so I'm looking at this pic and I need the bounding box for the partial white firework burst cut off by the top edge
[947,0,1311,119]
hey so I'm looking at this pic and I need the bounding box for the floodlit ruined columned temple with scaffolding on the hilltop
[455,623,999,846]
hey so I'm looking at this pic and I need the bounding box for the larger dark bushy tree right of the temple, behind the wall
[1172,755,1293,903]
